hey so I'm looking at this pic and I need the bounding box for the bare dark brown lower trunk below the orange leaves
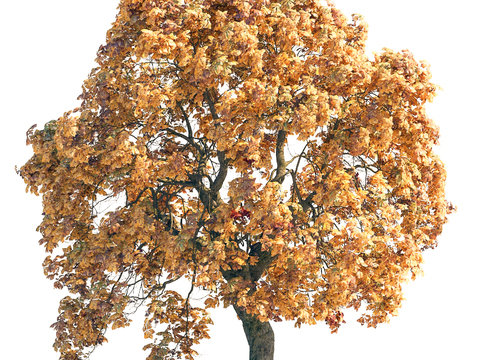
[233,305,275,360]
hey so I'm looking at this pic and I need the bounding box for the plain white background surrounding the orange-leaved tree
[0,0,480,360]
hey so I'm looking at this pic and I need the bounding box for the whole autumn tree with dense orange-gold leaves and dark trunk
[19,0,454,360]
